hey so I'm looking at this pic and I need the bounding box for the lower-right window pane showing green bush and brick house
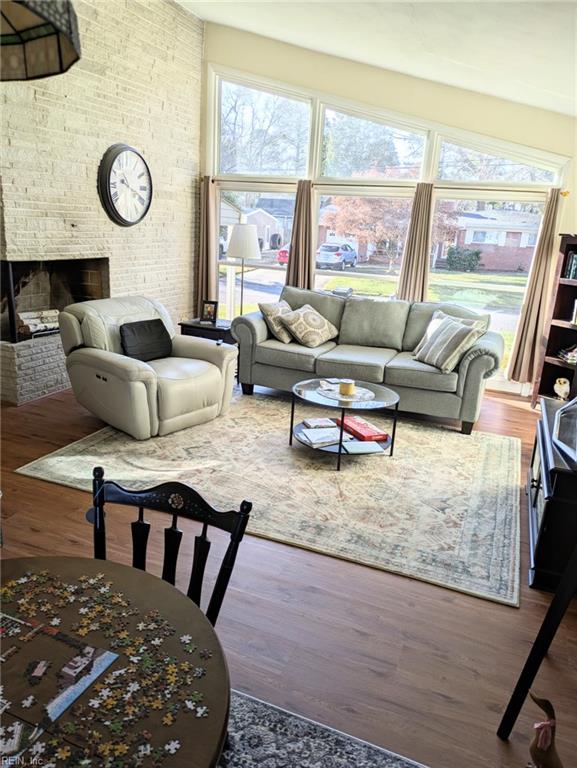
[429,199,543,368]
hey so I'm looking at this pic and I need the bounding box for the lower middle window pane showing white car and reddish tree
[315,194,412,296]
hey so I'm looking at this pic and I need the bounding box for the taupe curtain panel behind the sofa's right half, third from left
[397,184,433,301]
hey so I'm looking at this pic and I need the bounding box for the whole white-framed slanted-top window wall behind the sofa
[206,71,568,390]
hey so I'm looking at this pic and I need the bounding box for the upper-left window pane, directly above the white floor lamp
[218,80,311,178]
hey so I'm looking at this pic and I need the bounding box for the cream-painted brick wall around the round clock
[0,0,203,320]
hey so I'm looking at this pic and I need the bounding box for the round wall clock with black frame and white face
[98,144,152,227]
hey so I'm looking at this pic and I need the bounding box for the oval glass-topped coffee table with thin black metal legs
[289,379,399,471]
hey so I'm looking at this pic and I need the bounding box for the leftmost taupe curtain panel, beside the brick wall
[194,176,218,317]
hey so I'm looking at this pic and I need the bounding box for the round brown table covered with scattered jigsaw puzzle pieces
[0,557,230,768]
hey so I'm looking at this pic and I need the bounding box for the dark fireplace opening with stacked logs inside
[0,258,110,344]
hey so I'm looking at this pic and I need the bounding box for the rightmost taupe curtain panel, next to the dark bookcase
[507,188,561,384]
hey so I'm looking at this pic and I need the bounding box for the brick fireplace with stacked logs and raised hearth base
[0,258,110,405]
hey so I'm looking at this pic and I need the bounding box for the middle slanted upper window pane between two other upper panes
[321,107,425,180]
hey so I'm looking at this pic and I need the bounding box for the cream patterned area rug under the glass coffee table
[18,395,521,605]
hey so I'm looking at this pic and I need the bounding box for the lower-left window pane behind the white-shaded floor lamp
[218,189,295,319]
